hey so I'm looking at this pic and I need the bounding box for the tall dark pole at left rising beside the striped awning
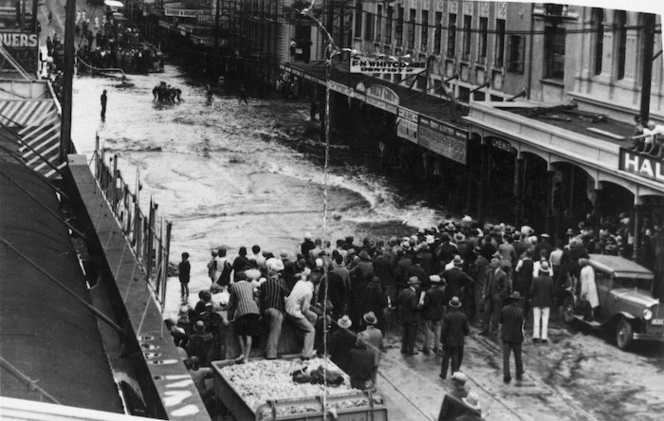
[60,0,76,162]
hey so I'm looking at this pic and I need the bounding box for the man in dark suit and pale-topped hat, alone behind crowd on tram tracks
[440,297,470,379]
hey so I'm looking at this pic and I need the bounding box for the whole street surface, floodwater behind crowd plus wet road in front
[72,66,664,421]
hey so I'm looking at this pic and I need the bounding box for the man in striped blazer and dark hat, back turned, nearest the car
[500,291,525,383]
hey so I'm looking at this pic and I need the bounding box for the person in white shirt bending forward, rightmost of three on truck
[286,272,321,359]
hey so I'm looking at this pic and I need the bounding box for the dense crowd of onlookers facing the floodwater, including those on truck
[169,213,648,419]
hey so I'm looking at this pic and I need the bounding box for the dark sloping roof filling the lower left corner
[0,160,124,413]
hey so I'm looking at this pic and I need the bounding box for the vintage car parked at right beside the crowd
[562,254,664,349]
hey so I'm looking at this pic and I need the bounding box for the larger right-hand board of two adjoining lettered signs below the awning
[417,116,468,164]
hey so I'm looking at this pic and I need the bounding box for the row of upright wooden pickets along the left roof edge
[94,137,172,311]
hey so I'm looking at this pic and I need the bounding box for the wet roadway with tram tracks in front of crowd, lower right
[378,318,664,421]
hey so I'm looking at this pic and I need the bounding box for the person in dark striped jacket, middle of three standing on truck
[260,271,286,360]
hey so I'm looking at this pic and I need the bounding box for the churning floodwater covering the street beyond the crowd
[72,66,442,285]
